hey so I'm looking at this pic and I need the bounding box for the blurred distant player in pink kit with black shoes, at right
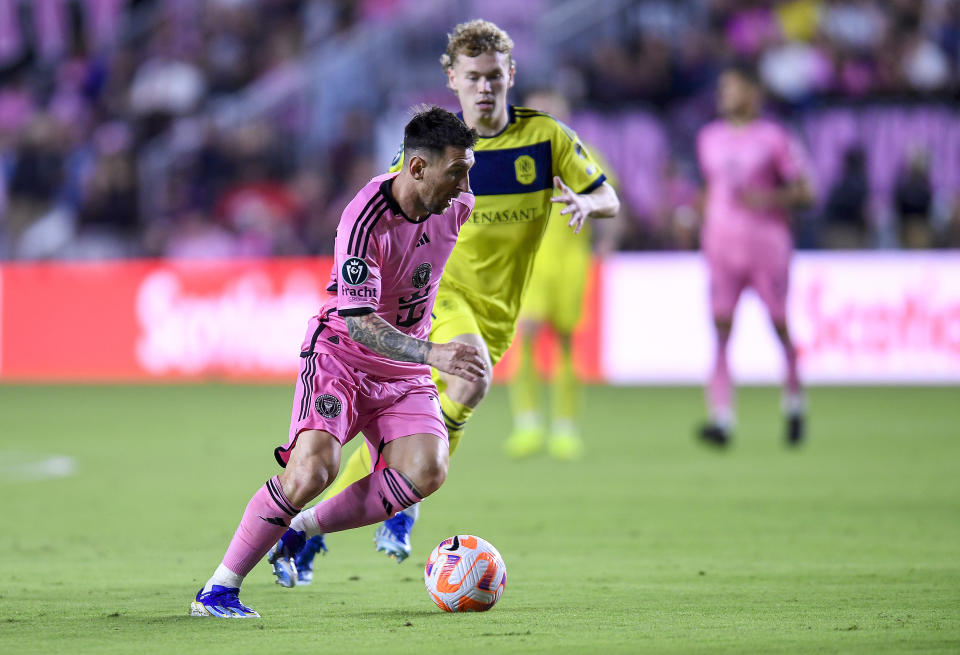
[697,68,812,446]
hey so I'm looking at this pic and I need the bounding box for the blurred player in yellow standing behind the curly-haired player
[504,89,617,460]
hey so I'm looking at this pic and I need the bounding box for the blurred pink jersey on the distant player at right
[697,120,806,264]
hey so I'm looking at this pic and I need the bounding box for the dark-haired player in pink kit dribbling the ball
[190,108,487,618]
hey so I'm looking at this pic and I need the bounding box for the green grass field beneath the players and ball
[0,385,960,655]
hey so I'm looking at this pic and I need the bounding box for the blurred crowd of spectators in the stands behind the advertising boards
[0,0,960,260]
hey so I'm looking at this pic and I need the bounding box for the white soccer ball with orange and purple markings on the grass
[423,534,507,612]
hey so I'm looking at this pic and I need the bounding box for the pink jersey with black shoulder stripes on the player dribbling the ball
[302,173,474,378]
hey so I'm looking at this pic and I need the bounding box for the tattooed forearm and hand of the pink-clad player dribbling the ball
[345,312,487,382]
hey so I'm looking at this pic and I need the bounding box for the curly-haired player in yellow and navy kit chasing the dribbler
[280,20,620,584]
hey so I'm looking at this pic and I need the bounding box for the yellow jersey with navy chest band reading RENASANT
[390,105,606,341]
